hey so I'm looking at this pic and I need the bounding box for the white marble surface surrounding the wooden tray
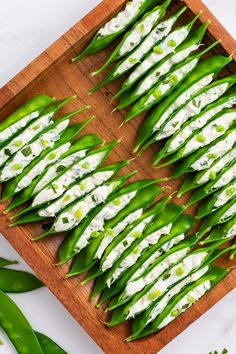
[0,0,236,354]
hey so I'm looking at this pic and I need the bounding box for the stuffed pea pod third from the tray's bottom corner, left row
[108,244,227,326]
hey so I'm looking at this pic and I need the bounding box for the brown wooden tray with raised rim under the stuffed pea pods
[0,0,236,354]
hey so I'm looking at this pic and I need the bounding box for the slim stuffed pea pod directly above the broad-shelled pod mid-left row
[33,170,135,241]
